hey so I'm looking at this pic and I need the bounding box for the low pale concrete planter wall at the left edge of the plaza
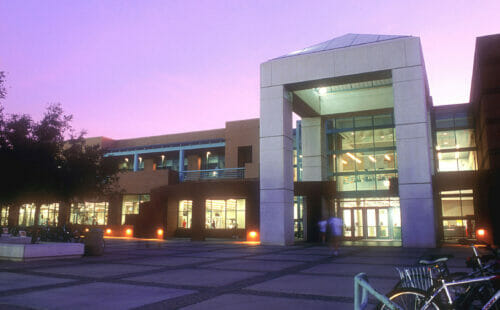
[0,243,84,261]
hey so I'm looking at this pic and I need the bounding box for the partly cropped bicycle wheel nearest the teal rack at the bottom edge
[379,288,442,310]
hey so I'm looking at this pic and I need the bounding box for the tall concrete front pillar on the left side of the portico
[260,85,294,245]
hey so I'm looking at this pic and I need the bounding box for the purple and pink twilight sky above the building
[0,0,500,138]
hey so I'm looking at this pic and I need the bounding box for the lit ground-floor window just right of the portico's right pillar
[439,189,475,239]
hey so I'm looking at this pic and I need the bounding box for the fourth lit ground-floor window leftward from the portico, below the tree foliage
[70,202,108,225]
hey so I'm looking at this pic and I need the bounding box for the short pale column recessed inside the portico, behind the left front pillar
[302,117,327,181]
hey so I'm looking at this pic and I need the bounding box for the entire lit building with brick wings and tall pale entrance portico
[0,34,500,247]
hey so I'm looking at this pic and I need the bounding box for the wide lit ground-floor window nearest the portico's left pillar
[205,199,245,229]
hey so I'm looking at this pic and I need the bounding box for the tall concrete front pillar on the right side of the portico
[392,65,436,247]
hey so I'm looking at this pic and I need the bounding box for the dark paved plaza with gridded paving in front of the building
[0,239,470,310]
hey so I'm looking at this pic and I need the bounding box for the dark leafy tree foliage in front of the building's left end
[0,104,118,213]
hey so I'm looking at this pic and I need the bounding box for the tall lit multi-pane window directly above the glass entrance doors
[326,114,397,191]
